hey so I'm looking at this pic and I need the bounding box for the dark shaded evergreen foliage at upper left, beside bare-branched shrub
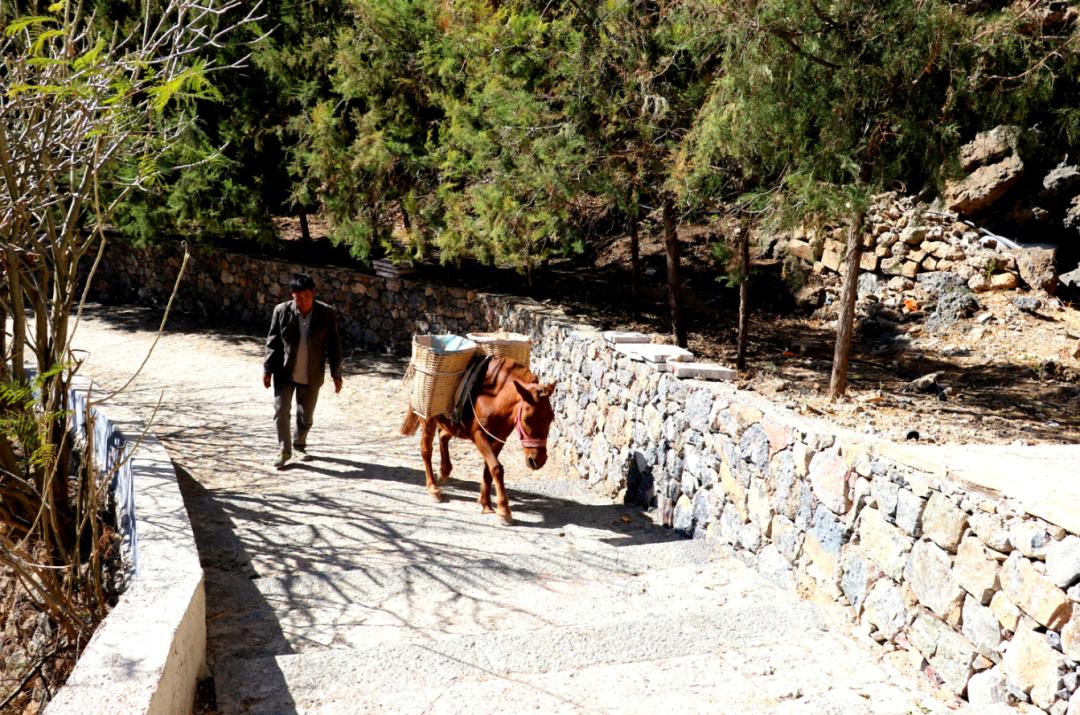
[103,0,346,242]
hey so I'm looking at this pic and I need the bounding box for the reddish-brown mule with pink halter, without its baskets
[401,358,555,524]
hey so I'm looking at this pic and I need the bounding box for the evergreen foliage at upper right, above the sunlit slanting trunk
[674,0,1078,220]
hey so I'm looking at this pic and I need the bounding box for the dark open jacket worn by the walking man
[262,300,341,388]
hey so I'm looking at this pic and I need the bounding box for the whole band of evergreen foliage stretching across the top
[46,0,1080,271]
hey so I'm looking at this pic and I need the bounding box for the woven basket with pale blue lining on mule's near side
[405,335,476,419]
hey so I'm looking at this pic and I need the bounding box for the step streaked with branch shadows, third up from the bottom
[207,540,721,661]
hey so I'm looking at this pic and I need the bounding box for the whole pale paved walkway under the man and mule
[69,308,963,715]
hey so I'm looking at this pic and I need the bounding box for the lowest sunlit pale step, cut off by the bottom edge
[276,649,954,715]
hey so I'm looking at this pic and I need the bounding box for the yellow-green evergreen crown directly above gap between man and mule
[294,0,442,258]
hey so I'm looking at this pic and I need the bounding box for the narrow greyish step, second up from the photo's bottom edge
[215,590,824,713]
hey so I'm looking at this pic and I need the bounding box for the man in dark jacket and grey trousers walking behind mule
[262,273,341,469]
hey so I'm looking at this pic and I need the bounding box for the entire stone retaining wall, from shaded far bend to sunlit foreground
[88,239,1080,715]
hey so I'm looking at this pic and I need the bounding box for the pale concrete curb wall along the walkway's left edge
[46,380,206,715]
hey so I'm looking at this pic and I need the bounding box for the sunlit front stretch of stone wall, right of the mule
[511,319,1080,715]
